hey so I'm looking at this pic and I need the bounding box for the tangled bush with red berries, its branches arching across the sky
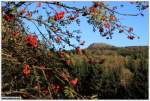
[2,1,148,99]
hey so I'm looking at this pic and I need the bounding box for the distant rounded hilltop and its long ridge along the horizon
[83,43,148,56]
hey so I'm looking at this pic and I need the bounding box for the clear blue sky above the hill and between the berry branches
[18,2,148,49]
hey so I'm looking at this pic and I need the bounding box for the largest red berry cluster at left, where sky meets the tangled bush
[26,35,38,48]
